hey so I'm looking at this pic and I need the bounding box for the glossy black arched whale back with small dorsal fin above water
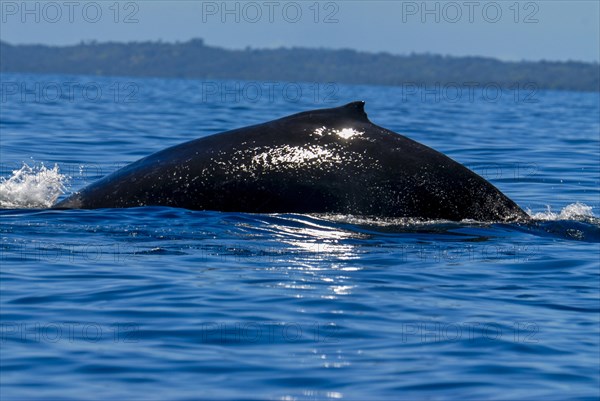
[55,102,528,221]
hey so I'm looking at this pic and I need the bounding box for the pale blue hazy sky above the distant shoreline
[0,0,600,61]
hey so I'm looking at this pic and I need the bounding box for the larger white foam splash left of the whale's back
[0,163,69,209]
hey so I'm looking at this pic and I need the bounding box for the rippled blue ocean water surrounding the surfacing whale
[0,74,600,400]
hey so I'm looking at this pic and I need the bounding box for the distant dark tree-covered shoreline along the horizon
[0,39,600,92]
